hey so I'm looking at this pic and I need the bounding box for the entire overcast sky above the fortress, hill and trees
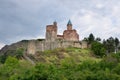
[0,0,120,48]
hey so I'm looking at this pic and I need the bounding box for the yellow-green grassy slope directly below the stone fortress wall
[34,47,101,64]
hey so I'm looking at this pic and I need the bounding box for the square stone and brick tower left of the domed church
[46,21,57,41]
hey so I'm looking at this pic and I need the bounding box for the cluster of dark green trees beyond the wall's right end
[84,33,120,57]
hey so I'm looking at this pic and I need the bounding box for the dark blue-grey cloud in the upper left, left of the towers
[0,0,72,44]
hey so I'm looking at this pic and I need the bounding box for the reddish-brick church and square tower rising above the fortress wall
[46,20,79,41]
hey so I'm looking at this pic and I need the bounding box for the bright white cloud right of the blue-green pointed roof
[72,4,120,39]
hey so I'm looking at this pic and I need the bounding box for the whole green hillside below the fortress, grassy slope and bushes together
[0,47,120,80]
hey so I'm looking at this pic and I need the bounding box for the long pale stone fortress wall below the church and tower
[27,40,87,54]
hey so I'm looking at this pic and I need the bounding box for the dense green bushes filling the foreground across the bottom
[0,47,120,80]
